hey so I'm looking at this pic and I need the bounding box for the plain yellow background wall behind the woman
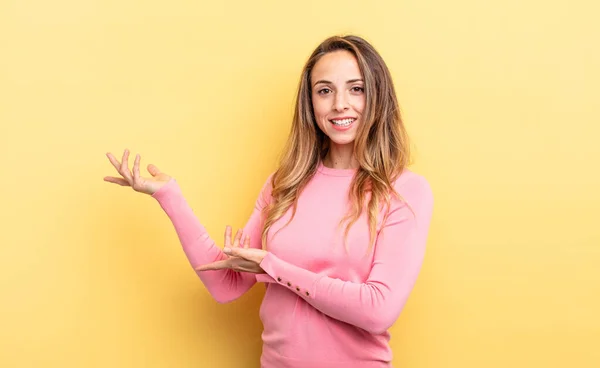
[0,0,600,368]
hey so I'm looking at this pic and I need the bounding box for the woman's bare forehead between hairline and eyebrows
[311,50,362,82]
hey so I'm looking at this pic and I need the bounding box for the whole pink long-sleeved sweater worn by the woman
[153,164,433,368]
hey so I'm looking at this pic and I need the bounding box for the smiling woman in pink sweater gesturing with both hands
[105,36,433,368]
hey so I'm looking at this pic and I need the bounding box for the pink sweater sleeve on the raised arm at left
[152,177,271,303]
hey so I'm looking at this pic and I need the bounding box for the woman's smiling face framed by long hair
[310,50,365,145]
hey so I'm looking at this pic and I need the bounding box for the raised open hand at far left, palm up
[104,149,171,195]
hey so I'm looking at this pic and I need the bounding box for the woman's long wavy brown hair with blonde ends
[262,35,410,251]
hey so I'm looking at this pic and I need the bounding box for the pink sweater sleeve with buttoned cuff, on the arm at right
[257,176,433,334]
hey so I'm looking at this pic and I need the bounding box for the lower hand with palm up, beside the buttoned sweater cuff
[194,226,267,273]
